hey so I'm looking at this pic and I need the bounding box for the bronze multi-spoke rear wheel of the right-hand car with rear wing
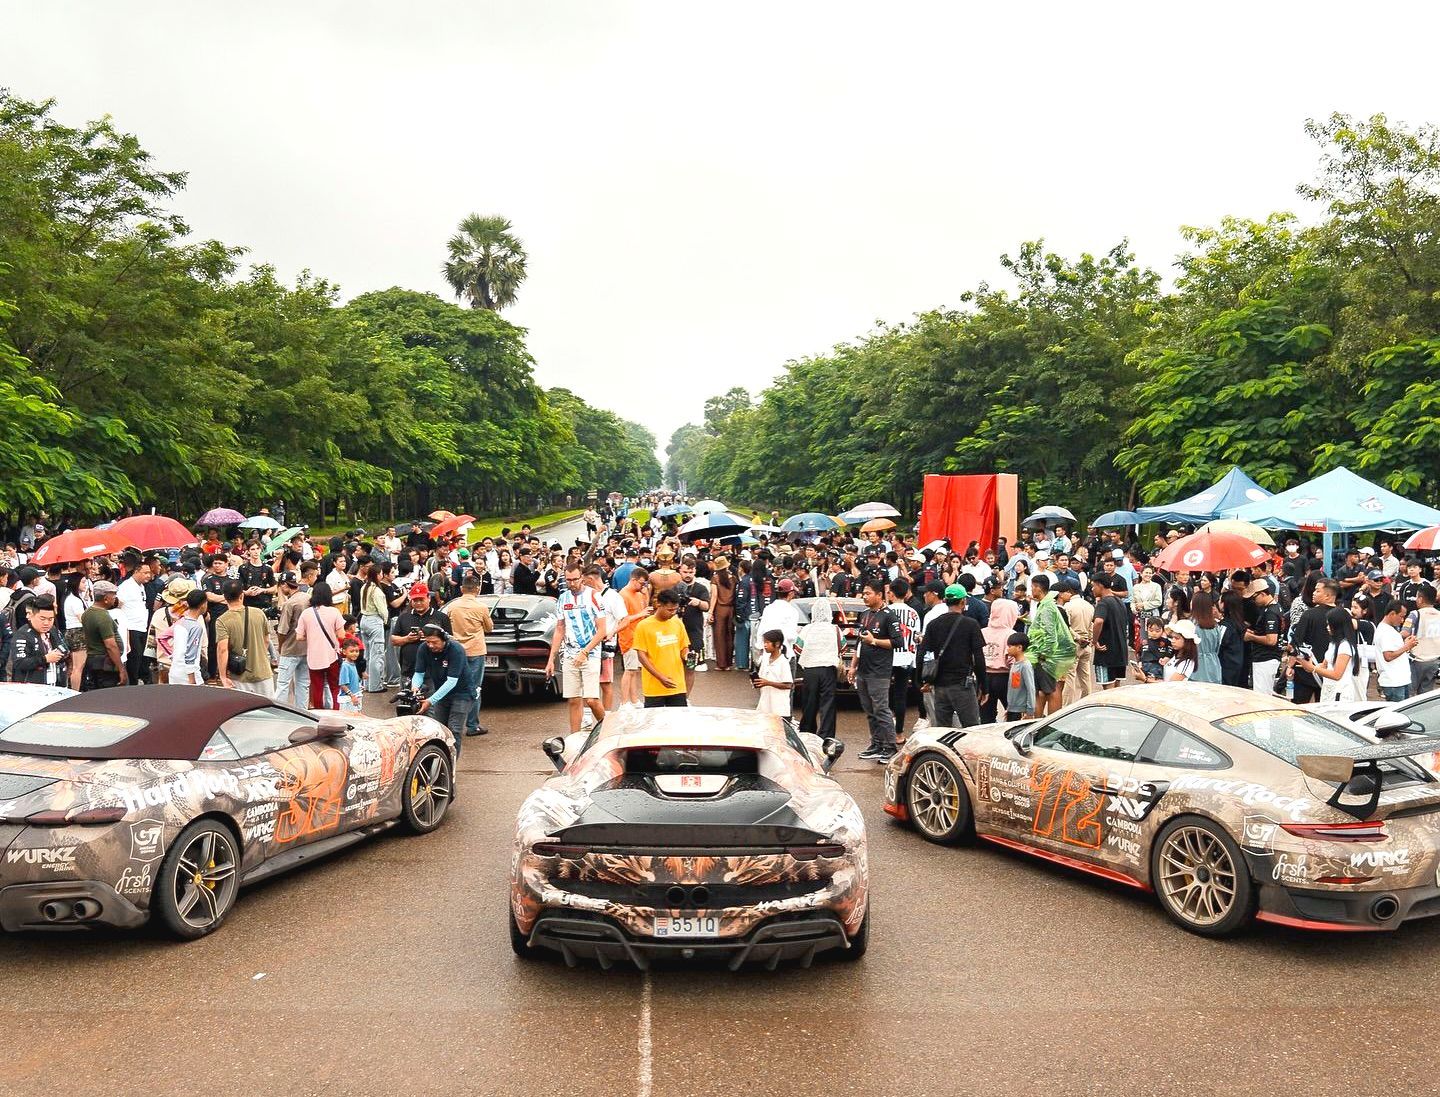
[1151,816,1254,937]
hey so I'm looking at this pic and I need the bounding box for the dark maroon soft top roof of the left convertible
[0,685,305,762]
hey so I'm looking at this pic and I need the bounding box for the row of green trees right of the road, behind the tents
[665,114,1440,515]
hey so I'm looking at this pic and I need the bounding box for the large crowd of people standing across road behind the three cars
[0,497,1440,762]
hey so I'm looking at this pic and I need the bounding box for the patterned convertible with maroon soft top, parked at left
[0,685,455,939]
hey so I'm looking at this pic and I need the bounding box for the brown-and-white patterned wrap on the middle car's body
[511,708,868,965]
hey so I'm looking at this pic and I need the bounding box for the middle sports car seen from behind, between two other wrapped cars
[510,708,870,969]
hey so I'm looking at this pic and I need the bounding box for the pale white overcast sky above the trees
[0,0,1440,448]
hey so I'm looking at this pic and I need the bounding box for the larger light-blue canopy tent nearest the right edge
[1225,468,1440,573]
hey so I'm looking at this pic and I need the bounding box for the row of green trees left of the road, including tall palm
[0,92,648,518]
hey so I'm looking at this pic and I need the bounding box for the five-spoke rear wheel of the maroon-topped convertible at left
[150,819,240,940]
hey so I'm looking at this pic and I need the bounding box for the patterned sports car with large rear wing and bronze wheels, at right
[884,682,1440,937]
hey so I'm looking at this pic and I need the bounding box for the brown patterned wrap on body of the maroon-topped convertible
[0,687,455,930]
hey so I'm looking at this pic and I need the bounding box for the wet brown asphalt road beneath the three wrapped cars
[8,526,1440,1097]
